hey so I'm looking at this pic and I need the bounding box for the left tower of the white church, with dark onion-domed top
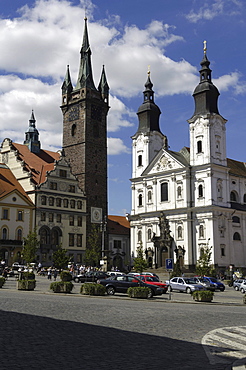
[132,72,168,178]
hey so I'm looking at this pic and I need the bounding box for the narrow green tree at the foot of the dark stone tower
[85,224,101,266]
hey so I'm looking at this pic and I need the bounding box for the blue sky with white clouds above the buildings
[0,0,246,216]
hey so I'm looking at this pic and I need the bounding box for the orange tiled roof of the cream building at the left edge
[0,163,33,204]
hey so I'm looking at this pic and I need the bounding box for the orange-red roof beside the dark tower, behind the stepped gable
[11,142,60,185]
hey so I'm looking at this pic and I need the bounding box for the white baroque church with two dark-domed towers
[129,44,246,271]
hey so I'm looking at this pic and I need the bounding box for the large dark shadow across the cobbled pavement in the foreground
[0,311,233,370]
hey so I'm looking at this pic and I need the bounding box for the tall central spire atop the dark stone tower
[75,17,96,90]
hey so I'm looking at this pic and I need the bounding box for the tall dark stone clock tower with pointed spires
[61,18,109,238]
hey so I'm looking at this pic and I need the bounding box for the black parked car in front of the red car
[98,275,163,298]
